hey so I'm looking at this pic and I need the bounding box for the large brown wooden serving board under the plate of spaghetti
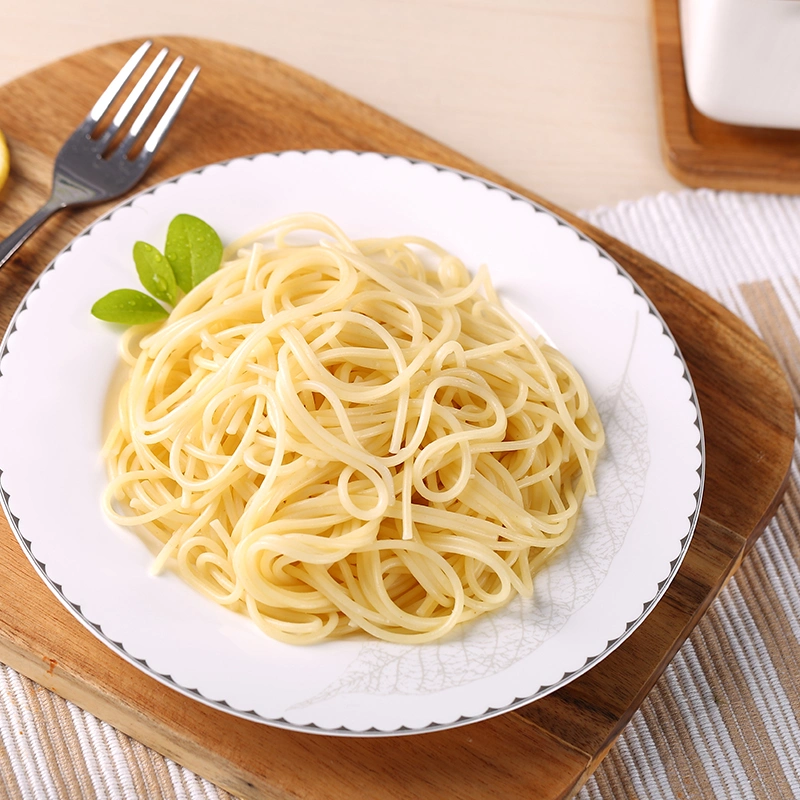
[0,39,795,800]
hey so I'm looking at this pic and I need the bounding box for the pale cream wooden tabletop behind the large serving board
[0,0,679,211]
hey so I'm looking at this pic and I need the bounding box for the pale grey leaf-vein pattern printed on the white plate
[294,318,650,708]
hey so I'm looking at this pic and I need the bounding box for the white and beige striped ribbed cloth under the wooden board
[0,190,800,800]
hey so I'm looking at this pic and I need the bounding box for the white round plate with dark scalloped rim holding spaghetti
[0,151,704,735]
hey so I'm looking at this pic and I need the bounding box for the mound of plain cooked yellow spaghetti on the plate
[104,215,603,643]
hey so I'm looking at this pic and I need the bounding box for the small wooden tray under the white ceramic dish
[652,0,800,194]
